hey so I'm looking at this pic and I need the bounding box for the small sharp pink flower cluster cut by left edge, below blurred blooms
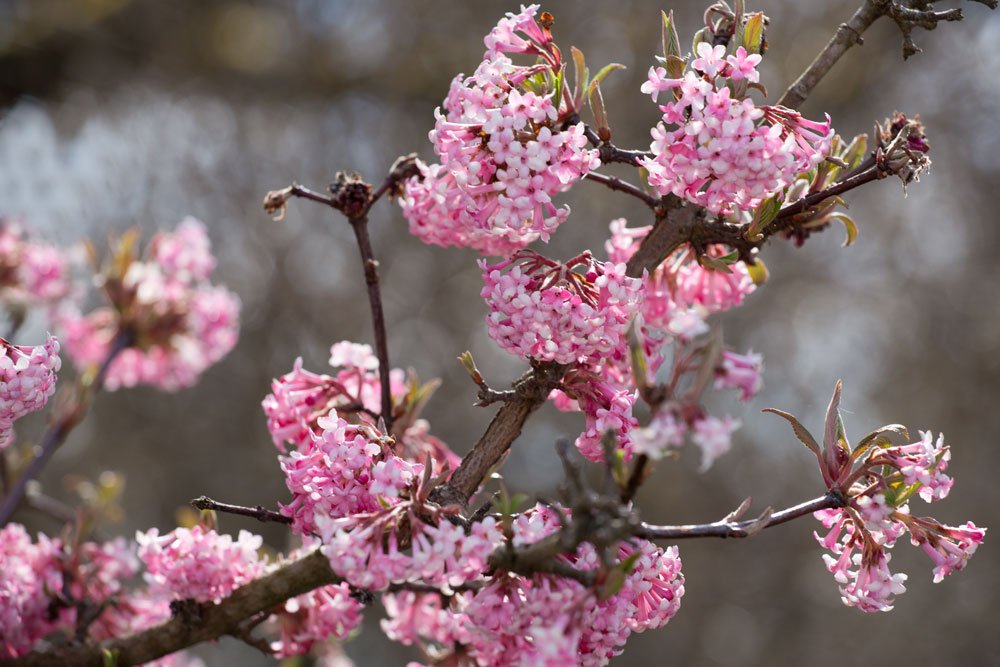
[0,336,62,451]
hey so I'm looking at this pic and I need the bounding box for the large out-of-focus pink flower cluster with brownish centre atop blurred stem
[59,218,240,391]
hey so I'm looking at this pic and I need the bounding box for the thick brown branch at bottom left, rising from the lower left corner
[4,551,338,667]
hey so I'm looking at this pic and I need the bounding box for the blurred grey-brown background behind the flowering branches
[0,0,1000,667]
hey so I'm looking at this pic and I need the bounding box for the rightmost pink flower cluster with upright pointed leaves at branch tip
[771,383,986,612]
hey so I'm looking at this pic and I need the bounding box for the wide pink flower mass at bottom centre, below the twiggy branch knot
[383,507,684,666]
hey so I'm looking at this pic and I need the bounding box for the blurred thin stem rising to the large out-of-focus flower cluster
[0,329,133,526]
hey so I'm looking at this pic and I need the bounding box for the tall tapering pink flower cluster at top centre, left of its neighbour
[400,5,600,255]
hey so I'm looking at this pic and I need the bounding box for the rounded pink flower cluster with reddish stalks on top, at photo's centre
[480,251,642,364]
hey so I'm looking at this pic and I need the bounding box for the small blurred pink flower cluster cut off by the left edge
[0,219,69,305]
